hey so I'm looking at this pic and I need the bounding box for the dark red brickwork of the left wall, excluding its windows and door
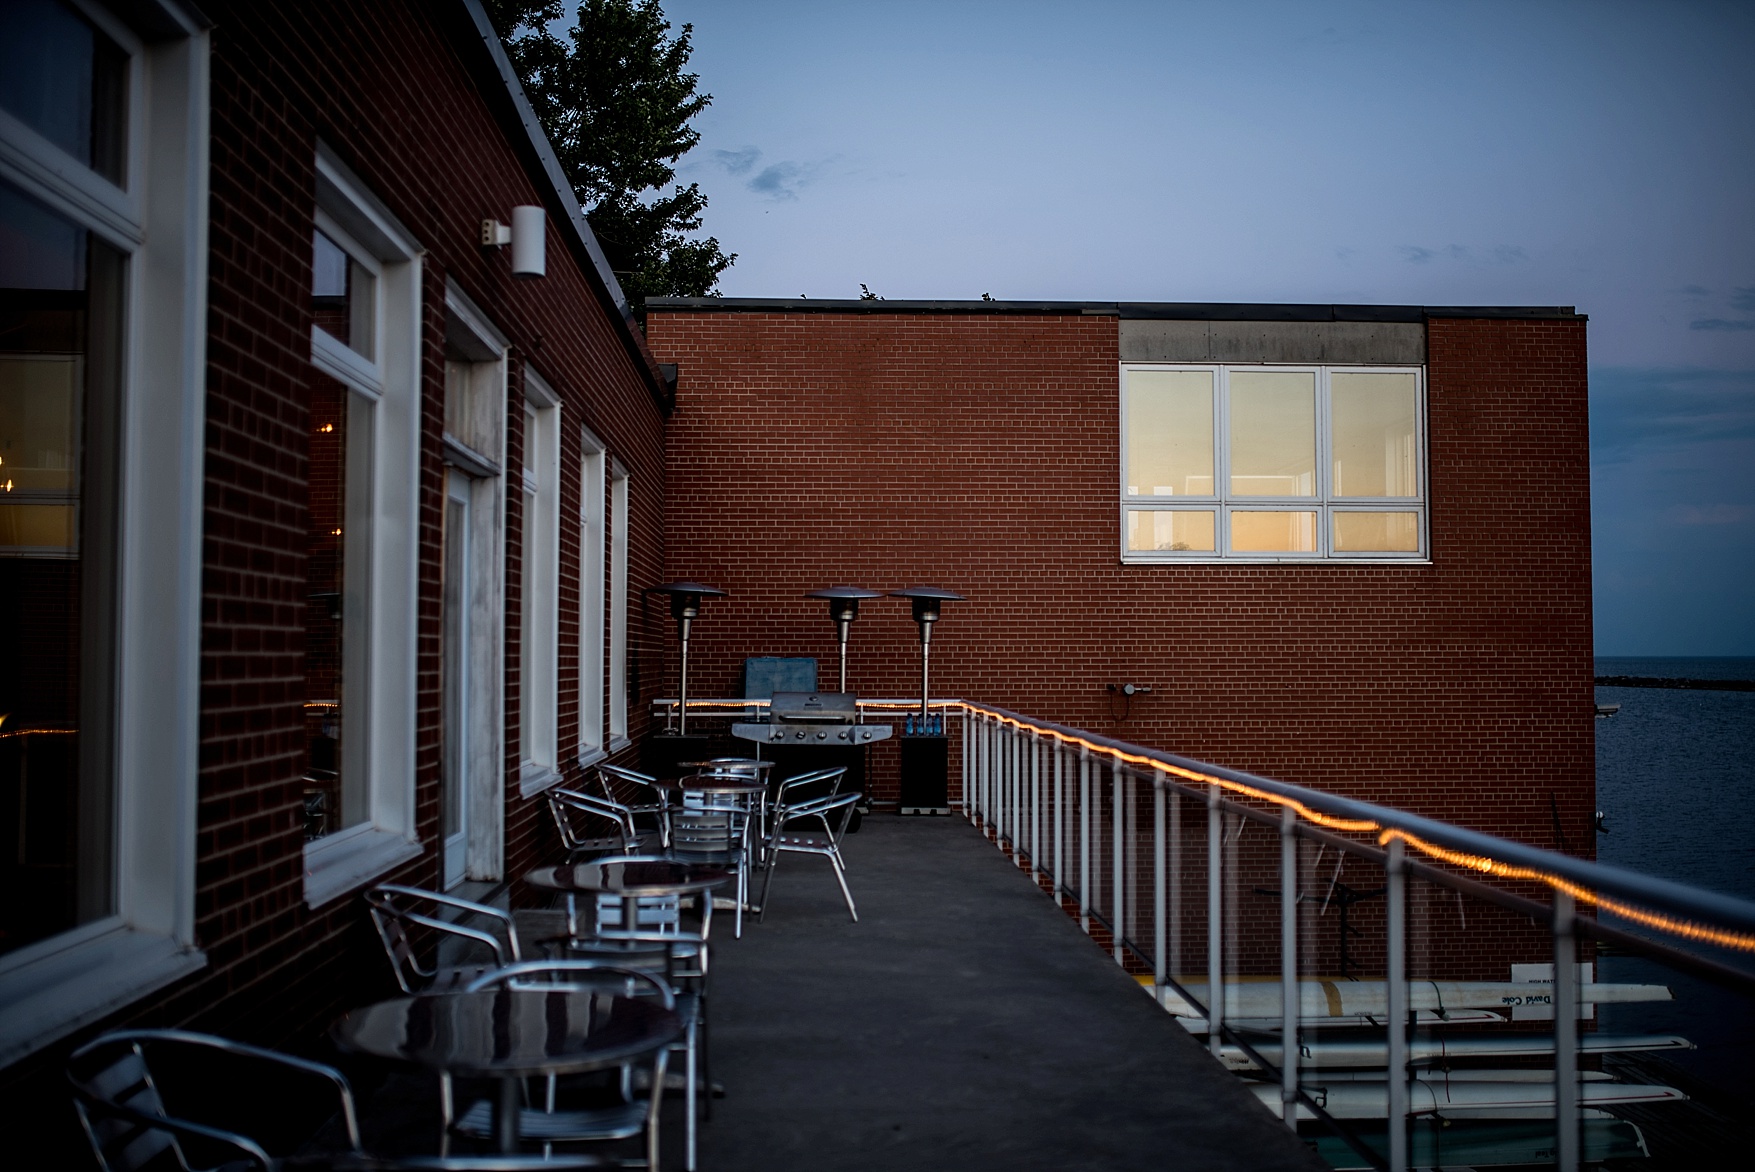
[7,0,663,1143]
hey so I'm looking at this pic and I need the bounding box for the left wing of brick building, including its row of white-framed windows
[0,0,669,1126]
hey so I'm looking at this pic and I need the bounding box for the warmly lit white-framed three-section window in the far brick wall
[1121,365,1427,561]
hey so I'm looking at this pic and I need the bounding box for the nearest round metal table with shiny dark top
[330,990,683,1153]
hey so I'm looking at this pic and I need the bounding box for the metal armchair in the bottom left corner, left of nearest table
[67,1030,363,1172]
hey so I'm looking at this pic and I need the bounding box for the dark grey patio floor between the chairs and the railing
[691,816,1327,1172]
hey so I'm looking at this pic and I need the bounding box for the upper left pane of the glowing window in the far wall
[1127,370,1213,497]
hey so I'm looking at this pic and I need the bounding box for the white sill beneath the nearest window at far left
[0,925,207,1067]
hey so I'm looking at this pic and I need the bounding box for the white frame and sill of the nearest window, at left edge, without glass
[0,0,209,1067]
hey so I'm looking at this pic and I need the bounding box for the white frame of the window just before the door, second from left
[304,142,423,907]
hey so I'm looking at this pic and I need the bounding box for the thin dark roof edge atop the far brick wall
[646,297,1587,323]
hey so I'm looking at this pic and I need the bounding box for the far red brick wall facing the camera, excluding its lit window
[648,312,1594,853]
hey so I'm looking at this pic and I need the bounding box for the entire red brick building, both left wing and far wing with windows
[0,0,1592,1137]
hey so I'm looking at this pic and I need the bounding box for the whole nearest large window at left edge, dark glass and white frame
[0,0,207,1065]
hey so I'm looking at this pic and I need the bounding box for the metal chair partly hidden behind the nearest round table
[441,960,673,1168]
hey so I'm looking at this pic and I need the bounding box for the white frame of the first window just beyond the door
[518,368,560,798]
